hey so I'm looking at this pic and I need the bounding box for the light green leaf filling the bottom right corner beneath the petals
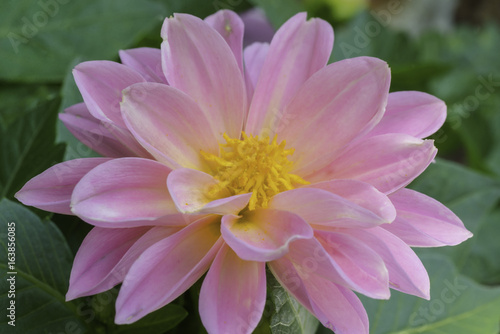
[361,255,500,334]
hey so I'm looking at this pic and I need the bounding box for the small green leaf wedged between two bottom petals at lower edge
[255,272,319,334]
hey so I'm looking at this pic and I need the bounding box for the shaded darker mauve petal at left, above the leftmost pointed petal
[59,103,151,158]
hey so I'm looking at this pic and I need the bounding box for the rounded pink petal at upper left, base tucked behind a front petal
[73,60,146,128]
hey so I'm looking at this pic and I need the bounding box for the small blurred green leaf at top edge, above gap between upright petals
[250,0,305,28]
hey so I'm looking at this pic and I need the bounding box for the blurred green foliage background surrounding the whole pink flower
[0,0,500,334]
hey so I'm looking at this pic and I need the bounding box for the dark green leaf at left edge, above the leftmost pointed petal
[0,99,64,198]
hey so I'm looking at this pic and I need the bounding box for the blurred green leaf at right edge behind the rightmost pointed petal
[411,160,500,283]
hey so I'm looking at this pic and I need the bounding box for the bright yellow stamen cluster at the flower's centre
[201,132,309,210]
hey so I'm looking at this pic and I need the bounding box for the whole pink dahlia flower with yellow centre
[17,11,471,334]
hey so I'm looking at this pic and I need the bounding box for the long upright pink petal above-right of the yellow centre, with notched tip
[246,13,333,138]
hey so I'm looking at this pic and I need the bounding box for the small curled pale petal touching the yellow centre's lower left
[167,168,252,215]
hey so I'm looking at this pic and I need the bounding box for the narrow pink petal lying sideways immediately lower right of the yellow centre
[269,188,390,228]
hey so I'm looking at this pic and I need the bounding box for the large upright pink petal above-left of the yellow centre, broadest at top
[161,14,247,141]
